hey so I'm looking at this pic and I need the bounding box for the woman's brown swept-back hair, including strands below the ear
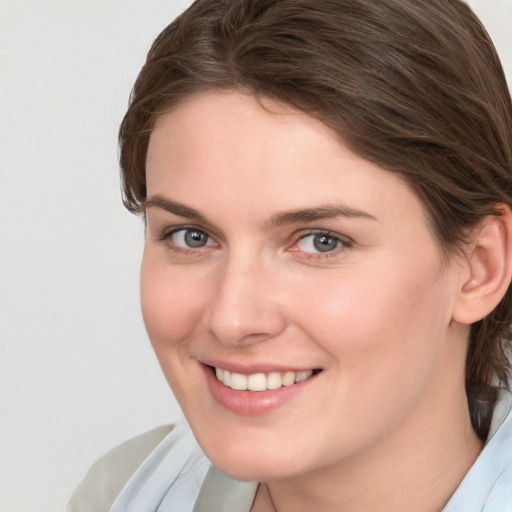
[119,0,512,437]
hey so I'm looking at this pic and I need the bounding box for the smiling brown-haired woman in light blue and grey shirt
[70,0,512,512]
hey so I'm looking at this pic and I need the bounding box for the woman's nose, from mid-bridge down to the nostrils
[207,258,286,346]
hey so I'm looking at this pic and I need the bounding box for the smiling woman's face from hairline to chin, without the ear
[141,92,467,480]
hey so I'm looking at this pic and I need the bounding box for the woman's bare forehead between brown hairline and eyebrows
[146,92,430,234]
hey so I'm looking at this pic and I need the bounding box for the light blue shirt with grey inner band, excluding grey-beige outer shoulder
[110,391,512,512]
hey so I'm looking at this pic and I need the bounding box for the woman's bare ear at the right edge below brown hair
[452,205,512,324]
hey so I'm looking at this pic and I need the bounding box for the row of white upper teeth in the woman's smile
[215,368,313,391]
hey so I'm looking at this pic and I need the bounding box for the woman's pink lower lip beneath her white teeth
[202,365,317,416]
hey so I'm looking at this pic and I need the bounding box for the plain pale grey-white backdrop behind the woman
[0,0,512,512]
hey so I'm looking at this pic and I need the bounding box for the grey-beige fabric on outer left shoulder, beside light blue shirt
[67,425,173,512]
